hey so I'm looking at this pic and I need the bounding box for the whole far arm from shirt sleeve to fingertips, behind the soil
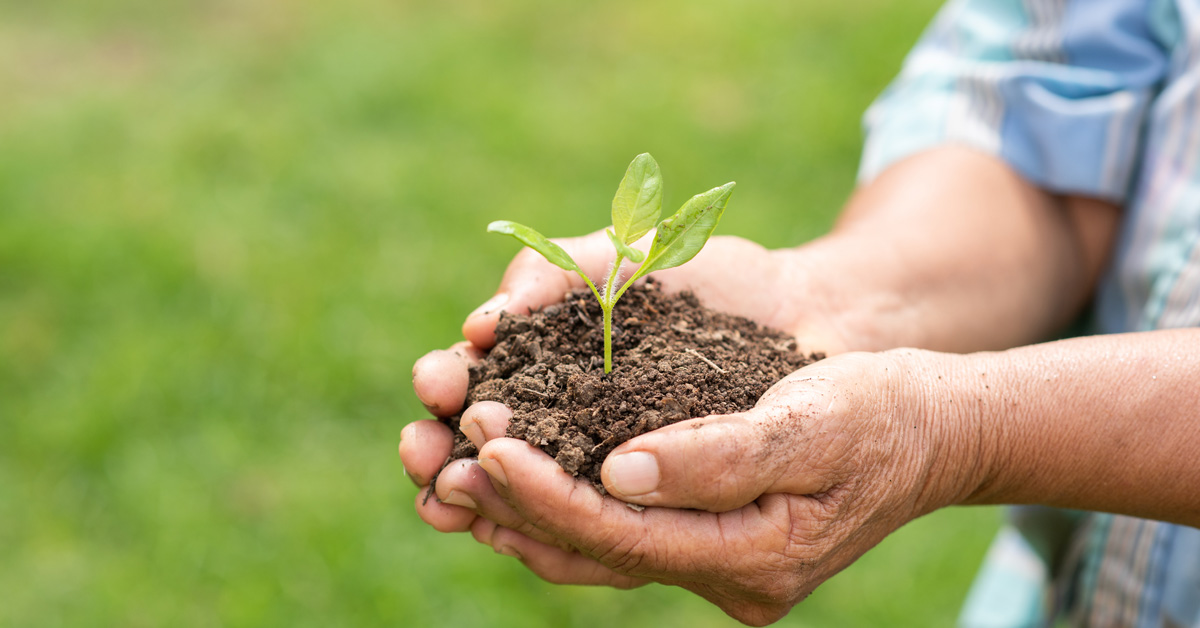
[400,146,1117,531]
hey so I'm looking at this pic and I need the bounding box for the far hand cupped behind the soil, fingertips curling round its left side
[400,232,847,532]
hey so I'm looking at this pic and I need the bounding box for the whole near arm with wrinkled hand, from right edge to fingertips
[453,330,1200,624]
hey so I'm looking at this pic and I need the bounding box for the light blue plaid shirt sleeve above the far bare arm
[859,0,1174,202]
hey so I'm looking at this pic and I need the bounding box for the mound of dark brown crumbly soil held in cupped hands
[448,282,823,492]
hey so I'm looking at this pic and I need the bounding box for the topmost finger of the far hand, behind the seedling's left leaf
[453,232,613,348]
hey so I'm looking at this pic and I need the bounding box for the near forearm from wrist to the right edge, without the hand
[938,329,1200,526]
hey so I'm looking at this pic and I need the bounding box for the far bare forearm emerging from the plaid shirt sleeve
[782,148,1117,352]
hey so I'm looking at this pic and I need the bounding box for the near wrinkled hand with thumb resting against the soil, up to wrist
[439,351,980,624]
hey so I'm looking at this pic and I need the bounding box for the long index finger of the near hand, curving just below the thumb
[480,438,772,579]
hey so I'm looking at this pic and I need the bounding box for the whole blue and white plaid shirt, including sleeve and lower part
[859,0,1200,628]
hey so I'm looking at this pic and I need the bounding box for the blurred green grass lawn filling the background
[0,0,996,628]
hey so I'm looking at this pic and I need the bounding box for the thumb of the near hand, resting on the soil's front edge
[600,407,829,513]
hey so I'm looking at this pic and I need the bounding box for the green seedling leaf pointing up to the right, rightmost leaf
[630,181,736,281]
